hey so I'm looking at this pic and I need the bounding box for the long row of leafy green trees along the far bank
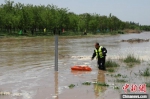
[0,0,150,34]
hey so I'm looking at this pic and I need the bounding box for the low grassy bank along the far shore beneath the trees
[0,29,141,37]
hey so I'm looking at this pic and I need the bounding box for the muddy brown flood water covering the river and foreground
[0,32,150,99]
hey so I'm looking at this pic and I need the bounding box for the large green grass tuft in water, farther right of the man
[123,54,141,63]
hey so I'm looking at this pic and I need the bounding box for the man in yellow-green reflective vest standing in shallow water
[91,43,107,70]
